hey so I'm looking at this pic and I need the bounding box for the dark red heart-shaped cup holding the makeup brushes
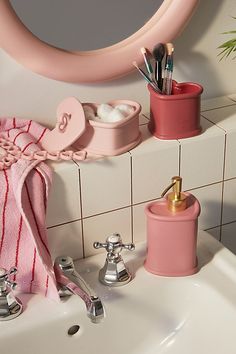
[148,81,203,140]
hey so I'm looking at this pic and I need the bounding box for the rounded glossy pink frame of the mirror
[0,0,199,83]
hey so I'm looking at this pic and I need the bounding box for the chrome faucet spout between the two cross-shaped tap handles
[54,256,104,323]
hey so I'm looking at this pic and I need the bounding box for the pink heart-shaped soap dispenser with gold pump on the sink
[144,176,200,277]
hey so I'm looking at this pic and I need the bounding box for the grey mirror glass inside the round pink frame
[10,0,163,51]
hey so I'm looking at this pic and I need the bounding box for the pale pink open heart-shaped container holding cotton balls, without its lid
[73,100,141,156]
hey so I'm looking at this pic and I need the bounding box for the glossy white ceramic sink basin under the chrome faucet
[0,232,236,354]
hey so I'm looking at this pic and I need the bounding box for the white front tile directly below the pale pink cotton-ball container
[79,153,131,217]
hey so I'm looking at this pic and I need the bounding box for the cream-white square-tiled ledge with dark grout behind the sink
[47,95,236,259]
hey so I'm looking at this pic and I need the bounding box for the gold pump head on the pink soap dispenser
[161,176,187,213]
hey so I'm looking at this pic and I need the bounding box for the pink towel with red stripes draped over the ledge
[0,118,58,299]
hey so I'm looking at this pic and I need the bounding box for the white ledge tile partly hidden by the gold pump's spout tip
[131,126,179,204]
